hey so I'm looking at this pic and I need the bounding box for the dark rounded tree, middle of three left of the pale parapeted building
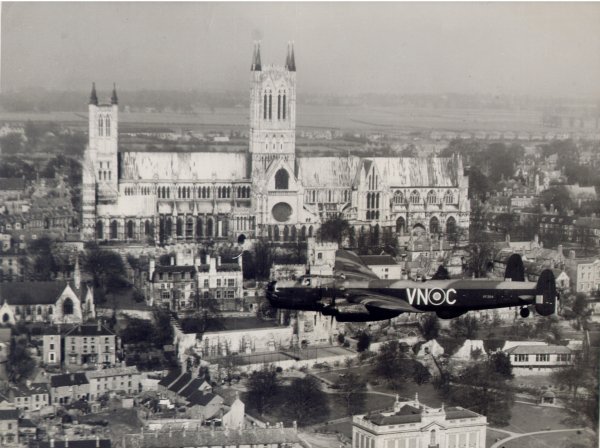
[285,375,329,424]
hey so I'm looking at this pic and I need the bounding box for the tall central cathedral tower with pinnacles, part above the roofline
[250,43,296,174]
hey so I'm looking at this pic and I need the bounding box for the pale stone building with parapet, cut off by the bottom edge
[352,397,487,448]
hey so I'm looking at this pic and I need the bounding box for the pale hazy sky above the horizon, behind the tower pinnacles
[1,2,600,97]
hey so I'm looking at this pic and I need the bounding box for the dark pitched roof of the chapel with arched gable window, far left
[0,281,67,305]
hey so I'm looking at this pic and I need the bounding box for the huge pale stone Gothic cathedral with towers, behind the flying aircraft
[82,44,470,244]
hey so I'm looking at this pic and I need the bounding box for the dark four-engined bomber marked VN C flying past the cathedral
[266,250,558,322]
